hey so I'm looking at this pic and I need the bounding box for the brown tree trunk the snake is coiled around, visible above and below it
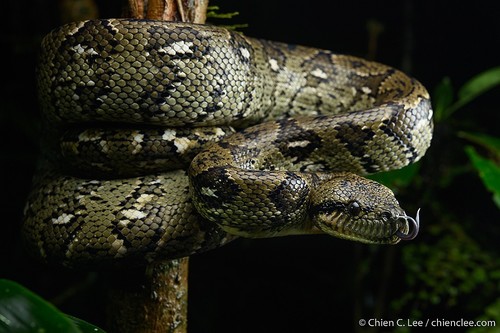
[107,0,208,333]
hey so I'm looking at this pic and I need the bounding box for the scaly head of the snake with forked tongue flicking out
[310,173,420,244]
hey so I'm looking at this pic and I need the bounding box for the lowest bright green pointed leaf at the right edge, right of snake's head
[465,146,500,208]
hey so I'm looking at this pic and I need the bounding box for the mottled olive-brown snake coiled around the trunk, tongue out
[22,19,433,268]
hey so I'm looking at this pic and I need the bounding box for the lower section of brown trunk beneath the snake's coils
[107,258,189,333]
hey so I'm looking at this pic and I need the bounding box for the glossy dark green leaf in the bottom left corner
[0,279,104,333]
